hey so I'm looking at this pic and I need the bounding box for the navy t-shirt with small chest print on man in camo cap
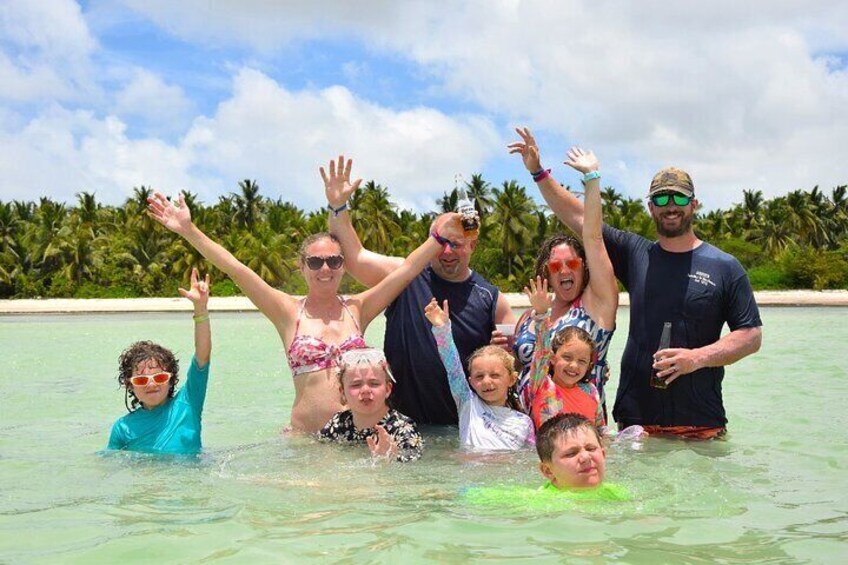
[604,225,762,427]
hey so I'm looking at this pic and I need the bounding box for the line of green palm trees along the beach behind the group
[0,174,848,298]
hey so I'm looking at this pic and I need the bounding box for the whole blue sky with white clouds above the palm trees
[0,0,848,210]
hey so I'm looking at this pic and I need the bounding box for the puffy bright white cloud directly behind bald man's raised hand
[178,69,500,209]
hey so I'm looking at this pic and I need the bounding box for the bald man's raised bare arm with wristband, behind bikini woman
[321,155,403,288]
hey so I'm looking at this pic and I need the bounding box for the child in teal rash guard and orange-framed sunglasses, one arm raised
[107,269,212,454]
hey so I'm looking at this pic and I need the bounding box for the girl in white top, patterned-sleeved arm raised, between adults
[424,298,535,450]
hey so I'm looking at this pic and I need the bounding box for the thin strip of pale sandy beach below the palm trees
[0,290,848,315]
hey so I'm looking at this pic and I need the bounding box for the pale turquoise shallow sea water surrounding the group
[0,308,848,563]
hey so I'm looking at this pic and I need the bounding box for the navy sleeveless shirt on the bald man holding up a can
[383,266,498,424]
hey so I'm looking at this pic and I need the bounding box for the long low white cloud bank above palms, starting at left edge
[0,69,500,209]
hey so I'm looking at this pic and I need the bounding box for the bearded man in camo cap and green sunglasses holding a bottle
[512,135,762,439]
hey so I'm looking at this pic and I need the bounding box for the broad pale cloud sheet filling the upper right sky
[117,0,848,207]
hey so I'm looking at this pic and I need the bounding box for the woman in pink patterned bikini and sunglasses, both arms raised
[148,163,463,433]
